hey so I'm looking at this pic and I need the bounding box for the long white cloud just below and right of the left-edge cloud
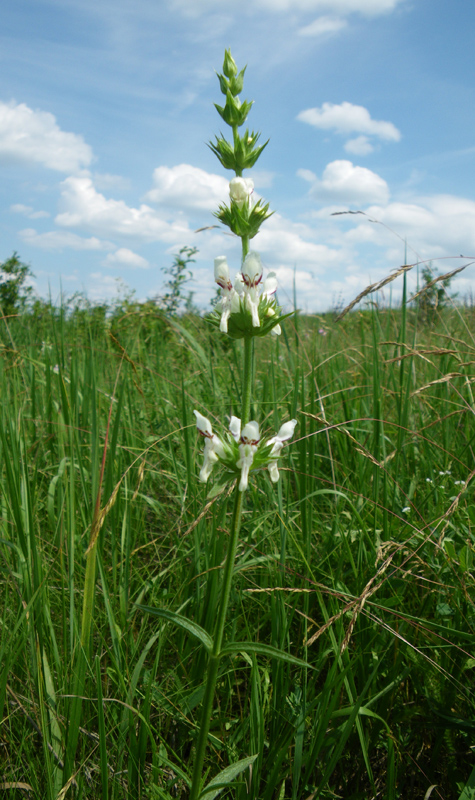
[55,176,191,245]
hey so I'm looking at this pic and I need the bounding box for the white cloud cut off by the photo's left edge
[0,101,92,172]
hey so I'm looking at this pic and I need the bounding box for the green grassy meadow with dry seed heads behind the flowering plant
[0,294,475,800]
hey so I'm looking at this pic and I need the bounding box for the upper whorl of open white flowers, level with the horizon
[211,251,281,339]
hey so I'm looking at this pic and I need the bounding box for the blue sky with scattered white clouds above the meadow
[0,0,475,313]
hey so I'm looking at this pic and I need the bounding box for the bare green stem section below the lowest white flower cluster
[190,483,243,800]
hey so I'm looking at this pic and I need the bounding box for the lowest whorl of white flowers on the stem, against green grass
[194,411,297,492]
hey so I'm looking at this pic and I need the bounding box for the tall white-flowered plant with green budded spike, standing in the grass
[143,50,303,800]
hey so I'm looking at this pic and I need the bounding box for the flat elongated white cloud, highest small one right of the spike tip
[297,101,401,142]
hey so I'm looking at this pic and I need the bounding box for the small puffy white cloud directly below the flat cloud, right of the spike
[297,160,389,204]
